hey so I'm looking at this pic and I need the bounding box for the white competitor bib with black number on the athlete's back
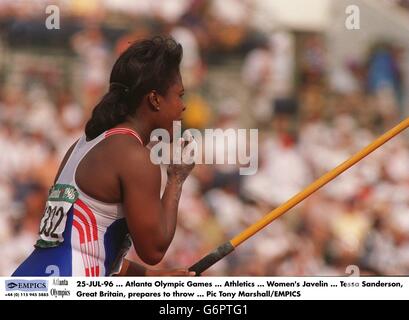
[35,184,78,248]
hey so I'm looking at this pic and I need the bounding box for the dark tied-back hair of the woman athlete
[85,36,183,140]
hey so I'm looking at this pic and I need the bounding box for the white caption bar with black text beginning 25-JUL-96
[0,277,409,300]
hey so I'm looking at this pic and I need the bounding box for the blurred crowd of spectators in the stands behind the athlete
[0,0,409,276]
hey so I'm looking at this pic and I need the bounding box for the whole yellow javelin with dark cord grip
[189,118,409,275]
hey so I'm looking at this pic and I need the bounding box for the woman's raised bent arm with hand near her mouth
[119,142,194,265]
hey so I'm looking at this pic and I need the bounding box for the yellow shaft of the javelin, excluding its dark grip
[230,118,409,248]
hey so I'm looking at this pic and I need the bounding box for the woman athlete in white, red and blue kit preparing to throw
[13,37,194,276]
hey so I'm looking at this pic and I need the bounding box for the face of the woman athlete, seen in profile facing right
[159,75,186,141]
